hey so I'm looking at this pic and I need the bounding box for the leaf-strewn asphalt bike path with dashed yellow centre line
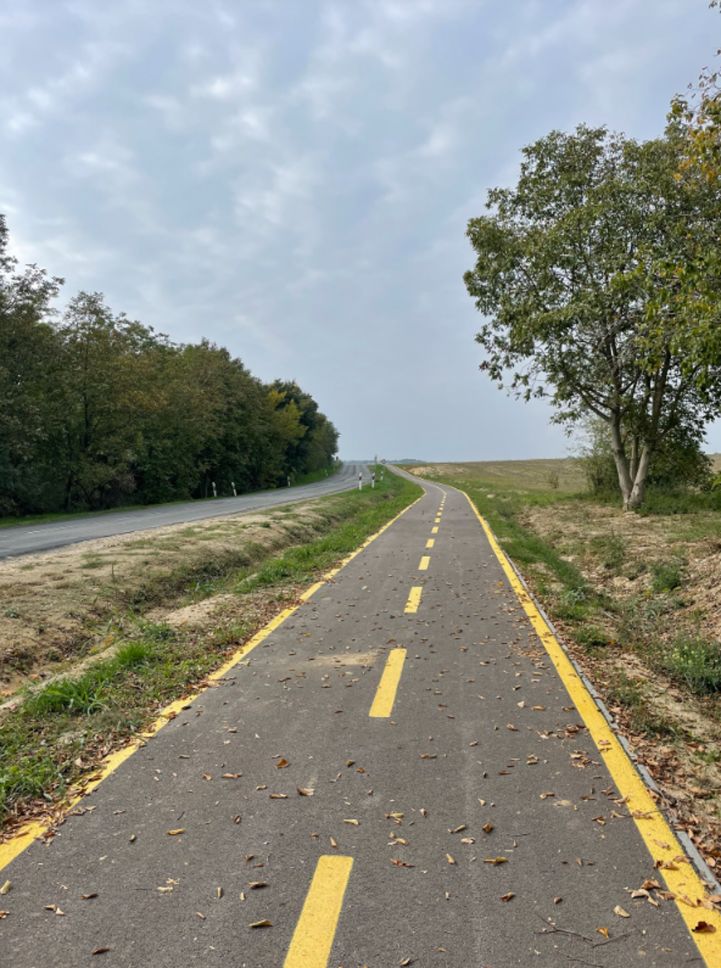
[0,472,718,968]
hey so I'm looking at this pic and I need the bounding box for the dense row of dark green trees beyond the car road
[0,215,338,516]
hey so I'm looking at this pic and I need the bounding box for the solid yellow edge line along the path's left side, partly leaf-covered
[0,494,425,871]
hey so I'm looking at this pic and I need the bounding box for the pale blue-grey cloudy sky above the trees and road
[0,0,721,460]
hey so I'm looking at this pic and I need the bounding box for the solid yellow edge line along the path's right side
[466,494,721,968]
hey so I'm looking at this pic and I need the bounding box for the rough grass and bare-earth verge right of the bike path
[414,460,721,870]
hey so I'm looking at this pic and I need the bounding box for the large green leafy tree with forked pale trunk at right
[464,126,721,509]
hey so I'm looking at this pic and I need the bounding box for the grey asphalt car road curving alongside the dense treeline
[0,463,369,560]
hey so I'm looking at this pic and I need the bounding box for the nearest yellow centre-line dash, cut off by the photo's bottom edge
[283,856,353,968]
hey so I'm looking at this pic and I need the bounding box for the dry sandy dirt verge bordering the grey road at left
[0,504,332,696]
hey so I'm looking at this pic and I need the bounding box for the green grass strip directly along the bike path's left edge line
[0,474,420,822]
